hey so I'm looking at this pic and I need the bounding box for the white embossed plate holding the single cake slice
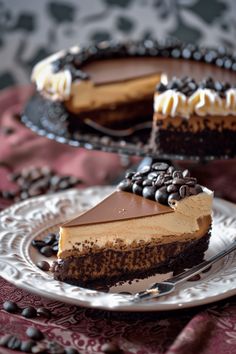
[0,187,236,311]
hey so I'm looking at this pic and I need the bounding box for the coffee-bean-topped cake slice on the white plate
[53,162,213,286]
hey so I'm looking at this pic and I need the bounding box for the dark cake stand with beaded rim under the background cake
[22,94,233,162]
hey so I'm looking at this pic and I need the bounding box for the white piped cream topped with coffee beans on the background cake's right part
[154,78,236,119]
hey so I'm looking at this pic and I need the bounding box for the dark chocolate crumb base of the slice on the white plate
[52,231,210,290]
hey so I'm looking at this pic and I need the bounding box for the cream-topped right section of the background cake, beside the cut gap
[151,77,236,158]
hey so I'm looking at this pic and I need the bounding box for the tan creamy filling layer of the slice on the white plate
[58,189,213,258]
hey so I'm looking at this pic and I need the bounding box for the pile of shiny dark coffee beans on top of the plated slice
[118,162,203,206]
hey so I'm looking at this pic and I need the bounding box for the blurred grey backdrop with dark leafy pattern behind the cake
[0,0,236,88]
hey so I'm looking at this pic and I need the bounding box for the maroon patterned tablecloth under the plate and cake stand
[0,87,236,354]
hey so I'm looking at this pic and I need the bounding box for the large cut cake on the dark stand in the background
[32,39,236,157]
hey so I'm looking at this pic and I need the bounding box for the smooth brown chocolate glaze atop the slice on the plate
[62,191,173,227]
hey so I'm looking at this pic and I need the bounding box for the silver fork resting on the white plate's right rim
[134,240,236,301]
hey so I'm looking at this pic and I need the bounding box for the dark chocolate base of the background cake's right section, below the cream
[150,125,236,159]
